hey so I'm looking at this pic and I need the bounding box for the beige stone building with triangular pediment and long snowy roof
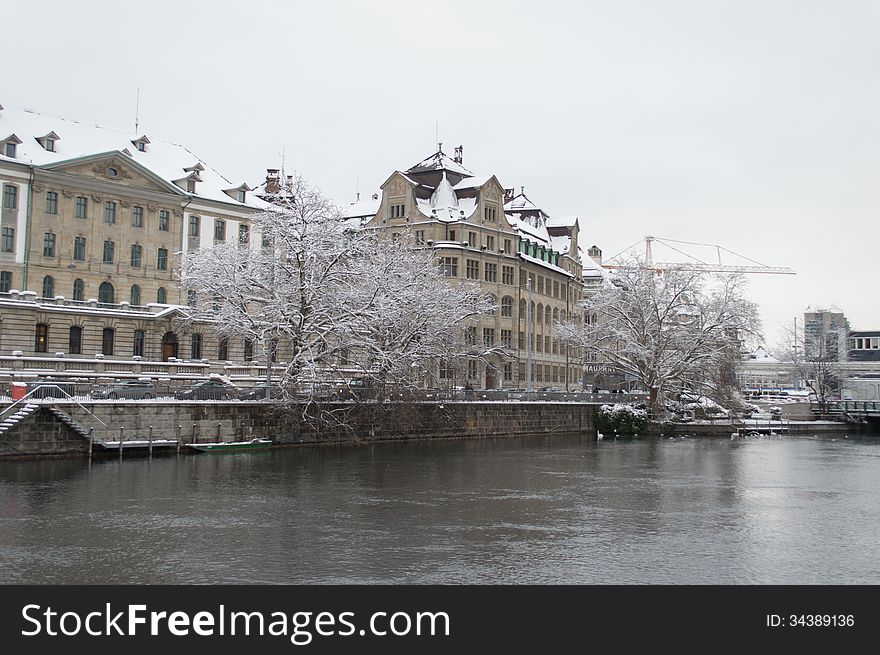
[0,107,267,360]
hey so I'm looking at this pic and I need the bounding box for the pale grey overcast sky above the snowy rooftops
[8,0,880,346]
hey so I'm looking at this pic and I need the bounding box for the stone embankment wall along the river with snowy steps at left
[0,402,597,456]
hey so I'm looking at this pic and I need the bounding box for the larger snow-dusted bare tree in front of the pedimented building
[181,178,492,399]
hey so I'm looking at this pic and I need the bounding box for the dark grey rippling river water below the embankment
[0,435,880,584]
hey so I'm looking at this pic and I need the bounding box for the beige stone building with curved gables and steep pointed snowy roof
[348,147,583,389]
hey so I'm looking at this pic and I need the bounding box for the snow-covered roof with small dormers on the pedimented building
[0,106,268,209]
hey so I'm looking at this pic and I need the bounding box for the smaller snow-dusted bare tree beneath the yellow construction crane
[560,260,759,415]
